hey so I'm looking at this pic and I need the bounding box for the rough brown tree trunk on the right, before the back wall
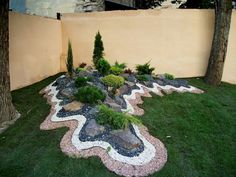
[205,0,232,85]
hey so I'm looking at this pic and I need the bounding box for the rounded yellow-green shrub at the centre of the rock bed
[101,74,125,89]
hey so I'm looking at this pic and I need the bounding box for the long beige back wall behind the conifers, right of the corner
[61,9,236,83]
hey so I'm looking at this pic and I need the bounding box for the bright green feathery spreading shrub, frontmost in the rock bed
[98,105,141,129]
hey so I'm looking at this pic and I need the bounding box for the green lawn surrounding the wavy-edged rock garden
[0,75,236,177]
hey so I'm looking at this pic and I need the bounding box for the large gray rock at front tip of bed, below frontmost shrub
[111,129,142,150]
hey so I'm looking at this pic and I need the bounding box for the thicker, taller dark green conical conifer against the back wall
[93,31,104,66]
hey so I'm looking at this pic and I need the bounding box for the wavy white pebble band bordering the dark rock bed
[41,75,203,176]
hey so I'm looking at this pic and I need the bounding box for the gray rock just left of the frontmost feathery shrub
[85,119,105,137]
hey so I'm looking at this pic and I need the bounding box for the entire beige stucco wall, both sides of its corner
[9,9,236,90]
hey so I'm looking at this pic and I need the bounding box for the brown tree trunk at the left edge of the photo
[0,0,18,124]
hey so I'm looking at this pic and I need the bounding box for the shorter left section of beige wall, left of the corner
[9,12,62,90]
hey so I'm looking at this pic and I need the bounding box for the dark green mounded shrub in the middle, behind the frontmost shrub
[75,86,106,104]
